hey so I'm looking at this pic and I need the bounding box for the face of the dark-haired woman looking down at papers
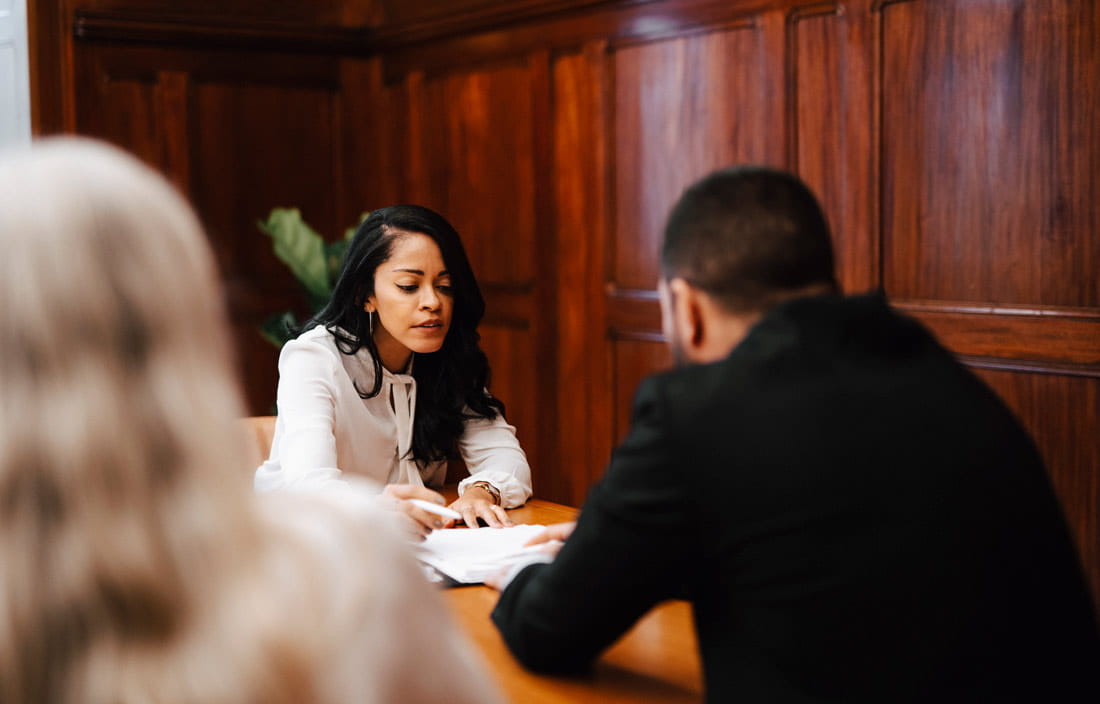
[363,232,454,372]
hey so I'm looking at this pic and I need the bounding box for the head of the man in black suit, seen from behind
[661,167,837,362]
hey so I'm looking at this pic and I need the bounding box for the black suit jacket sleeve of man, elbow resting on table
[493,380,699,672]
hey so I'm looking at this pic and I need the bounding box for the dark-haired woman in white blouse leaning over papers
[255,206,531,530]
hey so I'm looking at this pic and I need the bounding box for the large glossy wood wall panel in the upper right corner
[881,0,1100,307]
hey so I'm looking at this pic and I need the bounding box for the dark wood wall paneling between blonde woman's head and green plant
[74,43,343,414]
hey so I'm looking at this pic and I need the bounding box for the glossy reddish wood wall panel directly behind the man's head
[612,24,782,289]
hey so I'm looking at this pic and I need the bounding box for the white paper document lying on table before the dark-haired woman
[417,524,546,584]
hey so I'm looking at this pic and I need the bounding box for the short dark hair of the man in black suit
[661,166,837,312]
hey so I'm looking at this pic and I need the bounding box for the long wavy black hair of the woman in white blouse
[301,206,504,465]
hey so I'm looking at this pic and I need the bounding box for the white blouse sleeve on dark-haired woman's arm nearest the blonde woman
[268,340,341,486]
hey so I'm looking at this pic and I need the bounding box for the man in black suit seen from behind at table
[493,168,1100,702]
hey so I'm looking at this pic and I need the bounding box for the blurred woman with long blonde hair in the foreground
[0,140,498,704]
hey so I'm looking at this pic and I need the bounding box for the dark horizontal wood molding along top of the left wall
[73,10,372,56]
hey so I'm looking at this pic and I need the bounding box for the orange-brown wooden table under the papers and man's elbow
[444,499,703,704]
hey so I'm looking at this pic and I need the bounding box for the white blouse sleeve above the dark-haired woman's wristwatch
[459,416,531,508]
